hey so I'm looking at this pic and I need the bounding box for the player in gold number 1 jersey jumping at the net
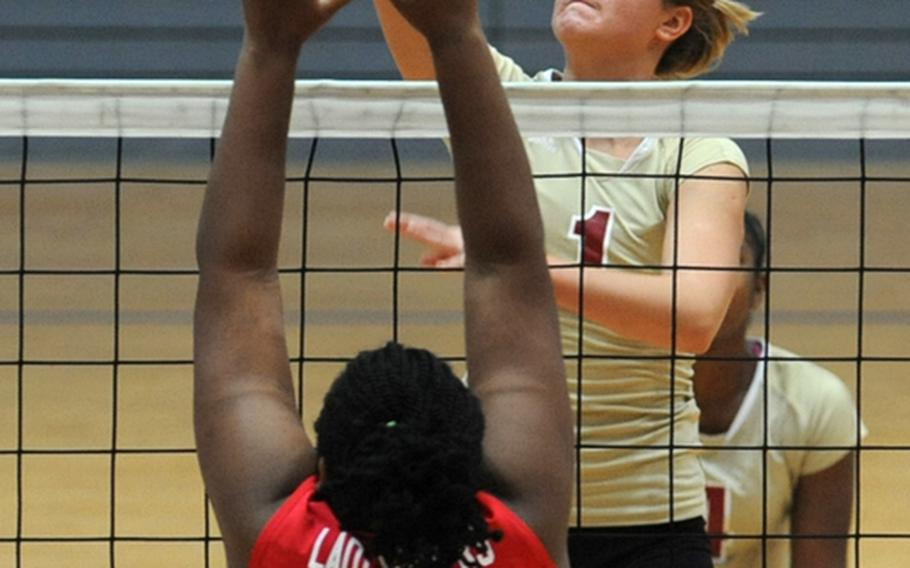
[375,0,756,568]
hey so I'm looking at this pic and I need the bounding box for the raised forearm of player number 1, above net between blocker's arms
[373,0,436,80]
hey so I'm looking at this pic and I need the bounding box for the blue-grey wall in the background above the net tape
[0,0,910,80]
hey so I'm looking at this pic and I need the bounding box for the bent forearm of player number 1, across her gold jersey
[550,258,735,353]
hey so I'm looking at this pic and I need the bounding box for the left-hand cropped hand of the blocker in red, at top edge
[243,0,350,54]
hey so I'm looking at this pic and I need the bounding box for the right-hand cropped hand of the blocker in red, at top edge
[392,0,480,44]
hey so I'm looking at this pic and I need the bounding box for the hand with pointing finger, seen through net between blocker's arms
[383,211,464,268]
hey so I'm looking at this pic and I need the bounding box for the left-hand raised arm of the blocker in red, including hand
[193,0,345,566]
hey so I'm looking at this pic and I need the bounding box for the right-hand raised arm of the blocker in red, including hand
[388,0,573,563]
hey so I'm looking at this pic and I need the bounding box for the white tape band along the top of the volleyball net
[0,80,910,139]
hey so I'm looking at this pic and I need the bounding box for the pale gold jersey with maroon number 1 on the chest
[492,46,748,526]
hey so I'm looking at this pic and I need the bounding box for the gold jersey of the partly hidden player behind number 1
[701,345,866,568]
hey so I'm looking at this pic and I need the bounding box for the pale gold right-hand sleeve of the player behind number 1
[799,365,866,477]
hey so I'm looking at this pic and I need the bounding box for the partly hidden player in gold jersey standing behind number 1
[694,213,862,568]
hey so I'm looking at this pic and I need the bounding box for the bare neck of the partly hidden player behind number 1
[693,330,758,434]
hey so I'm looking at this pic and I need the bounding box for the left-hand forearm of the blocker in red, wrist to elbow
[196,42,297,272]
